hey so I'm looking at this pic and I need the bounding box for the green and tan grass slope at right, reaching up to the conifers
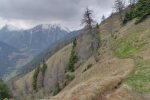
[113,16,150,93]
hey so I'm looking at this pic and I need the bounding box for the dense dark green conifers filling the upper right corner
[123,0,150,24]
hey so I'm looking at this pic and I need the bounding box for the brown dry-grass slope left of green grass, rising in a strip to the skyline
[50,15,134,100]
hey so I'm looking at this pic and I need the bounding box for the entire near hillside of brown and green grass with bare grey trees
[12,13,150,100]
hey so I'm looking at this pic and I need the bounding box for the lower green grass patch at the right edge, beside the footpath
[125,59,150,92]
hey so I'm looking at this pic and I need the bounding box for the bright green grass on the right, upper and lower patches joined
[111,30,150,93]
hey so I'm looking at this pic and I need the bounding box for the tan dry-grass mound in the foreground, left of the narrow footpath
[50,55,134,100]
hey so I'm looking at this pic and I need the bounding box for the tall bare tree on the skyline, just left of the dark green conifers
[114,0,125,21]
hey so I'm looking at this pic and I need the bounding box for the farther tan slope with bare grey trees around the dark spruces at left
[12,45,71,100]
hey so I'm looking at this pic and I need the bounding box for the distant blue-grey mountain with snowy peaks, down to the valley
[0,24,76,77]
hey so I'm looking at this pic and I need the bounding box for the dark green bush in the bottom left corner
[0,79,11,100]
